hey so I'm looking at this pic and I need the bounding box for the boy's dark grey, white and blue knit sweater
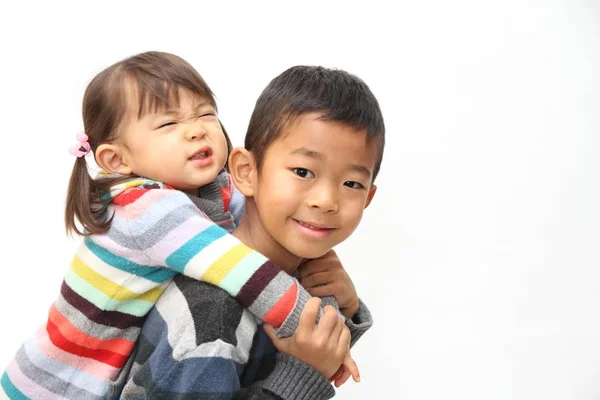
[115,275,372,400]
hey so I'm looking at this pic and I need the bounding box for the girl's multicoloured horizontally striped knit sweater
[0,173,310,400]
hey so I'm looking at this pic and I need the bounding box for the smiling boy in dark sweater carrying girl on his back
[121,66,385,399]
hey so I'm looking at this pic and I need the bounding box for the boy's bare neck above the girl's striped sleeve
[232,198,302,275]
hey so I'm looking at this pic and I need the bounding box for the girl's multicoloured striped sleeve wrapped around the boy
[125,189,311,337]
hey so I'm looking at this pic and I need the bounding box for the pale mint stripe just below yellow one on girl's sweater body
[65,268,154,317]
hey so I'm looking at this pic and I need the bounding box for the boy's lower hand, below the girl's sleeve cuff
[264,297,360,382]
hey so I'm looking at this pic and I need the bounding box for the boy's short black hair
[244,65,385,181]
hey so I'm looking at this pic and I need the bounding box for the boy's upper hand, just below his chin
[298,250,358,318]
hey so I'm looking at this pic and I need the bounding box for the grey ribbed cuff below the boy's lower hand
[263,353,335,400]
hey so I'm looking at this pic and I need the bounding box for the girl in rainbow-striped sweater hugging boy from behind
[1,52,356,399]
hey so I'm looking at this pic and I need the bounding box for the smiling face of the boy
[253,112,377,258]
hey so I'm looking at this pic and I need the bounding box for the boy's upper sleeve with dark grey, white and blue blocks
[121,275,258,399]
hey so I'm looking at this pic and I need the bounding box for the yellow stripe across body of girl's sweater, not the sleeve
[71,255,165,303]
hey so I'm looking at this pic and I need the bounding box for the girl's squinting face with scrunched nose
[105,89,227,193]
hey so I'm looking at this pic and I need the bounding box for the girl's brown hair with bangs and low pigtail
[65,51,232,236]
